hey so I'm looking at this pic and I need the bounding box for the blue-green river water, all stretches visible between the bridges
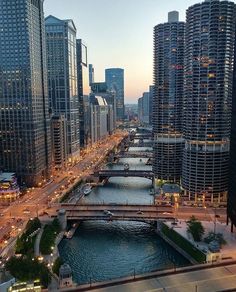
[59,148,188,284]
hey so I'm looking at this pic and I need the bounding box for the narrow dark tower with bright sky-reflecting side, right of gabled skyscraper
[76,39,89,148]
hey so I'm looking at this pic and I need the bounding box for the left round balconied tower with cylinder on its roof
[152,11,185,182]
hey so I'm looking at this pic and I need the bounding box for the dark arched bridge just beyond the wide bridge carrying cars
[94,169,154,181]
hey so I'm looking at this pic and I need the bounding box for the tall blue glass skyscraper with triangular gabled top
[45,15,80,162]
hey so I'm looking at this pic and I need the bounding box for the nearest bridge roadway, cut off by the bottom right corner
[61,262,236,292]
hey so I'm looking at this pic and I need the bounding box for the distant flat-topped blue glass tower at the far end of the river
[105,68,124,120]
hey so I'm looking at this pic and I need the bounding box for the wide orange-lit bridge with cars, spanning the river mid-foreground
[53,203,174,222]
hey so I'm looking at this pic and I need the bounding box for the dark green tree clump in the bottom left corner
[6,256,51,288]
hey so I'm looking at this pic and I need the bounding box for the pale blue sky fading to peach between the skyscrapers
[44,0,233,103]
